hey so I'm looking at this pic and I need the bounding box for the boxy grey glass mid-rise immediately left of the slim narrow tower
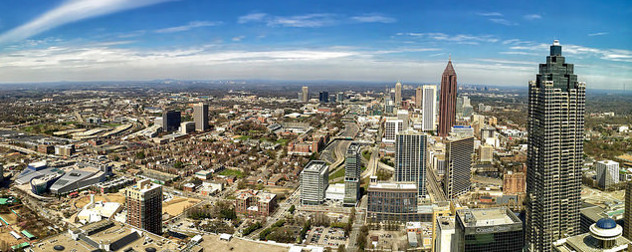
[300,160,329,205]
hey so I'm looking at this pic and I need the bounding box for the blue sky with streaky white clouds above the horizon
[0,0,632,90]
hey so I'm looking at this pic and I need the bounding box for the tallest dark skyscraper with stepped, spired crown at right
[526,40,586,251]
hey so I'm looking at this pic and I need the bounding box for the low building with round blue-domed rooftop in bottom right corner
[553,218,630,252]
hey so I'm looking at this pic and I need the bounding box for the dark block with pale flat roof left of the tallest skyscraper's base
[452,207,524,252]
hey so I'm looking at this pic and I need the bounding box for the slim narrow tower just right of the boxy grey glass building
[343,143,362,206]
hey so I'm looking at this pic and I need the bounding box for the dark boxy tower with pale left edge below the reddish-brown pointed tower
[443,135,474,198]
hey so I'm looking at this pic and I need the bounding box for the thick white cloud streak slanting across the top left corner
[0,0,172,43]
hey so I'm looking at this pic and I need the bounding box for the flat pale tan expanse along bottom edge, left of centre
[200,235,288,252]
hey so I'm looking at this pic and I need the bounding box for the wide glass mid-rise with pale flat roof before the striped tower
[367,182,419,222]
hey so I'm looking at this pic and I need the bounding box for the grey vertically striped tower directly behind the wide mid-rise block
[394,130,428,196]
